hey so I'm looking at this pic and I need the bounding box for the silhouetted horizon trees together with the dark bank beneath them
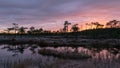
[1,20,120,38]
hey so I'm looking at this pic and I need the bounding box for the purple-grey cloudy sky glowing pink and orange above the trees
[0,0,120,30]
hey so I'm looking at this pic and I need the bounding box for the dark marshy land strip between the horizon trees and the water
[0,28,120,48]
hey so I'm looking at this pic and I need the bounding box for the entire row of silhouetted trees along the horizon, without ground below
[2,20,120,34]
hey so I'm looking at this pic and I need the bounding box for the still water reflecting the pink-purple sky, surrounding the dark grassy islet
[0,45,120,68]
